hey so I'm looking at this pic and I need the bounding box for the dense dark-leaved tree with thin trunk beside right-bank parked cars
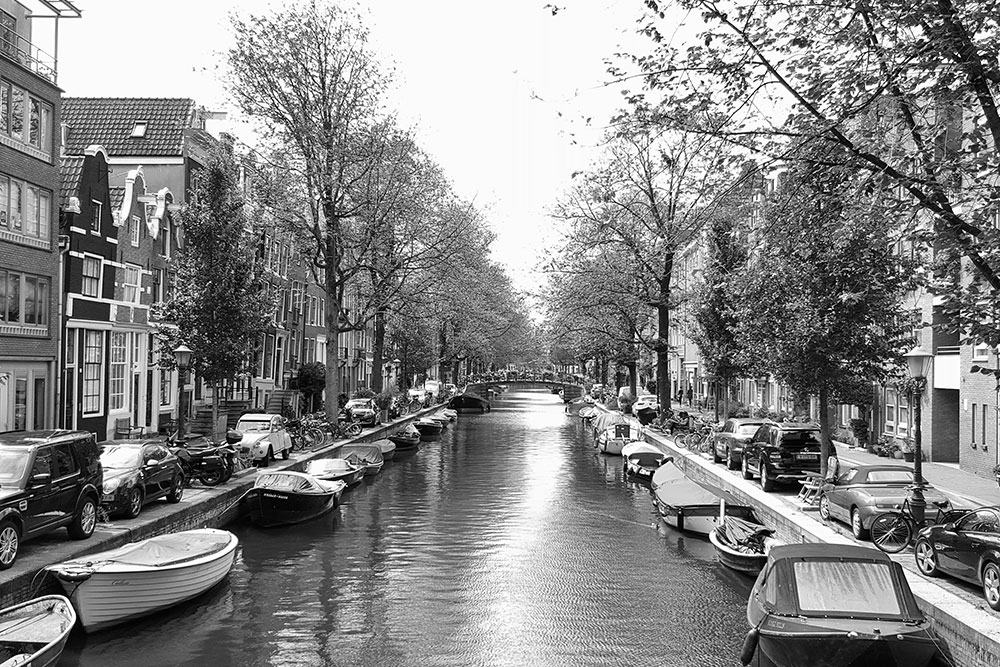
[735,149,918,471]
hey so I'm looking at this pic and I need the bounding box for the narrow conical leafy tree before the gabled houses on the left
[157,140,274,436]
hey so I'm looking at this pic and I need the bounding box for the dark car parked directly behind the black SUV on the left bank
[100,440,184,519]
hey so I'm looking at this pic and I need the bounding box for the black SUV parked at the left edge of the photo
[0,431,103,570]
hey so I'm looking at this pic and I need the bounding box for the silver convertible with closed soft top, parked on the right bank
[819,465,949,540]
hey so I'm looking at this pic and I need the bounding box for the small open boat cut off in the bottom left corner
[0,595,76,667]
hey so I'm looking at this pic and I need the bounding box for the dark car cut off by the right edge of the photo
[913,506,1000,611]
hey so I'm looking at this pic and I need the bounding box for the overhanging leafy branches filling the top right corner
[628,0,1000,345]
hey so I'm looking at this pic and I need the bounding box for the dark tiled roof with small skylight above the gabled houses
[62,97,196,157]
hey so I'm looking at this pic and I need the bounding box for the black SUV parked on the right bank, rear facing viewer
[742,423,820,491]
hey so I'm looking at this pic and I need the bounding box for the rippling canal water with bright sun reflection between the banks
[59,392,752,667]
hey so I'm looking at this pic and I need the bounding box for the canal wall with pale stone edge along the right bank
[645,431,1000,667]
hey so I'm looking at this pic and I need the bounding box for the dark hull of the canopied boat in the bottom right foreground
[757,618,937,667]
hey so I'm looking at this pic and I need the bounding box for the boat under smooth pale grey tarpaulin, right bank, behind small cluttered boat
[651,461,756,537]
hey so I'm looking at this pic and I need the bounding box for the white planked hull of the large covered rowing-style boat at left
[53,536,238,632]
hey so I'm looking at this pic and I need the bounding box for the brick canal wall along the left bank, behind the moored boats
[0,405,444,608]
